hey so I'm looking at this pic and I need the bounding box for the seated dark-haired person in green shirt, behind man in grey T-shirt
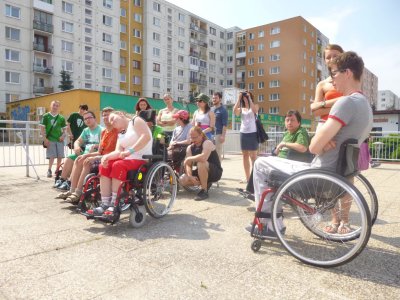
[239,110,309,200]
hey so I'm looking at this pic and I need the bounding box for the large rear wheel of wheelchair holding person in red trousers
[143,162,178,218]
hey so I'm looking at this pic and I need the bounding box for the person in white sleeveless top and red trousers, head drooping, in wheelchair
[87,111,153,215]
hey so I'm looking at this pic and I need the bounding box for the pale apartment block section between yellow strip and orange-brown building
[143,0,238,102]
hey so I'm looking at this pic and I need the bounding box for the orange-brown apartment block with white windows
[236,17,328,119]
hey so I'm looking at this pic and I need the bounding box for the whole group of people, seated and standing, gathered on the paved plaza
[41,44,372,236]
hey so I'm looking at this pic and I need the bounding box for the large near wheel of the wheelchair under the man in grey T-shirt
[272,170,371,267]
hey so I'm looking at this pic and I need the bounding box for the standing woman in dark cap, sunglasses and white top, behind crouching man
[192,93,215,141]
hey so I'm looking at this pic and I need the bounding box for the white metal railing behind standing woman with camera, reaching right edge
[224,131,400,162]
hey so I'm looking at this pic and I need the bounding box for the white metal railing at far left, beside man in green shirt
[0,120,69,177]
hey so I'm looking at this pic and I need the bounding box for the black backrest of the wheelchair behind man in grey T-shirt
[336,138,360,177]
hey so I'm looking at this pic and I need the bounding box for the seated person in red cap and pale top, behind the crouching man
[168,110,193,163]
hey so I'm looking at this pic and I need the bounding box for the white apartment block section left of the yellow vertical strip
[0,0,120,112]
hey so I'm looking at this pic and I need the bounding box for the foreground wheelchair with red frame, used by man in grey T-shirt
[251,140,377,268]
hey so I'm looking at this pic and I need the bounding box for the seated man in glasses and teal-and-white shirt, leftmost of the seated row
[54,111,103,191]
